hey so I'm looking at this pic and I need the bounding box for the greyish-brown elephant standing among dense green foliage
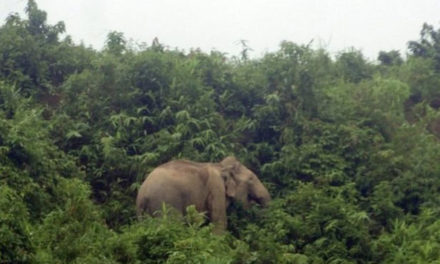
[136,156,271,233]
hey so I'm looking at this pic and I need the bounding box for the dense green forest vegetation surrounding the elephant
[0,0,440,264]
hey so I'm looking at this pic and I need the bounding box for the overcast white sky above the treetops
[0,0,440,59]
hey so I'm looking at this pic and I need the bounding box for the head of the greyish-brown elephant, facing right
[220,157,271,208]
